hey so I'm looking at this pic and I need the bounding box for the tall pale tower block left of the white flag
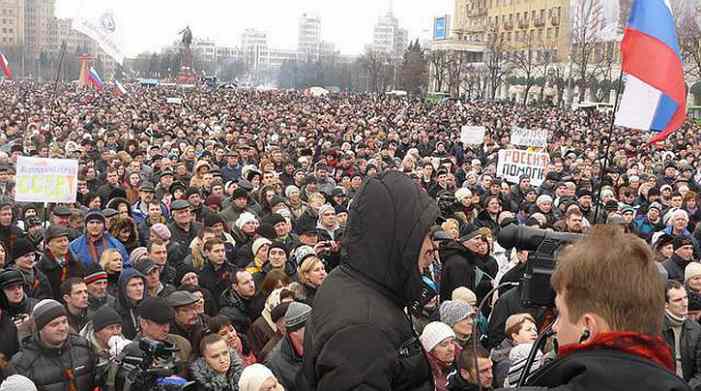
[24,0,56,59]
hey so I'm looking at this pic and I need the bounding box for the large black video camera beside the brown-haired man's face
[497,224,584,307]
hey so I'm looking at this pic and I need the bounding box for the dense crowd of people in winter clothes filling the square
[0,82,701,391]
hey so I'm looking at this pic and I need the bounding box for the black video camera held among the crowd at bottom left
[121,338,194,391]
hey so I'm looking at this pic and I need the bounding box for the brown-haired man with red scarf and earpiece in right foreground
[516,226,689,390]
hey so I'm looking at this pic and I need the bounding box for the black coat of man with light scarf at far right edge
[662,316,701,389]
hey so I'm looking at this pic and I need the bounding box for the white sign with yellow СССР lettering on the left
[15,157,78,203]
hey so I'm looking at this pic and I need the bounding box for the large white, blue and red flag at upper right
[615,0,686,143]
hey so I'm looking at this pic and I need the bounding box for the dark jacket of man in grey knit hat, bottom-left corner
[11,334,98,391]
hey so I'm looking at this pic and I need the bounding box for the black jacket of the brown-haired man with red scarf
[522,349,691,391]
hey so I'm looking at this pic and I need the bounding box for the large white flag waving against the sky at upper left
[73,3,126,65]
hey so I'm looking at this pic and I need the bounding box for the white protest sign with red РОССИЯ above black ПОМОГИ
[497,149,550,186]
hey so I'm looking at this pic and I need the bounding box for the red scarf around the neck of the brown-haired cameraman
[558,331,674,372]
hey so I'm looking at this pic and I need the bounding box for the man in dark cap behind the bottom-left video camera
[108,297,192,391]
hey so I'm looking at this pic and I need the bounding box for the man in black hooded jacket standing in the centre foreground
[297,171,439,391]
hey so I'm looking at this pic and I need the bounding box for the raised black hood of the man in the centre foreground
[344,171,439,305]
